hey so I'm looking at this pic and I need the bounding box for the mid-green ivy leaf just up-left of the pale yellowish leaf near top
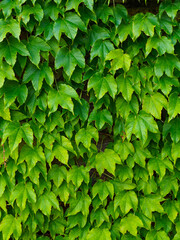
[90,39,114,63]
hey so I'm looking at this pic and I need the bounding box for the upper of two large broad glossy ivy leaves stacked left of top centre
[53,12,86,41]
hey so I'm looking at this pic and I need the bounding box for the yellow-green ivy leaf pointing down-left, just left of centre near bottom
[67,192,91,217]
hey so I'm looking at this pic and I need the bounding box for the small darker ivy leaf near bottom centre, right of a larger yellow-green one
[90,207,109,227]
